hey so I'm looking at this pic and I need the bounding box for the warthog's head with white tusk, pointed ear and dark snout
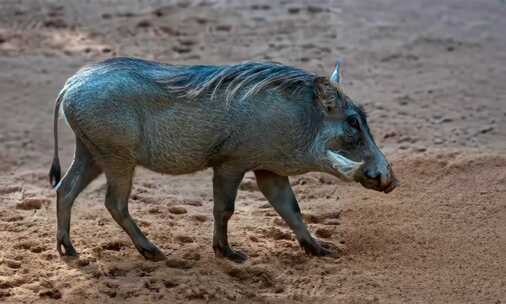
[313,59,399,193]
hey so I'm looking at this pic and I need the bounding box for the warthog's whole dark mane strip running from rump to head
[88,58,316,103]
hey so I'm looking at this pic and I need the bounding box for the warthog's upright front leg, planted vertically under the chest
[213,168,247,263]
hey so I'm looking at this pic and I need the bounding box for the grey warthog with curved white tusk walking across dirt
[49,58,398,262]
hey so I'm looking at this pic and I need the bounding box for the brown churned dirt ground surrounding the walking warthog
[0,0,506,304]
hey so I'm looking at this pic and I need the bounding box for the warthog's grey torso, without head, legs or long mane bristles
[62,59,322,174]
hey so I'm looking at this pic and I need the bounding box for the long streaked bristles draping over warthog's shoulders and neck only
[156,62,316,104]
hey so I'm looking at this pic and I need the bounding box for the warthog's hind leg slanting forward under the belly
[105,163,165,261]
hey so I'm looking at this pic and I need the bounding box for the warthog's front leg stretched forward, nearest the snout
[255,170,332,256]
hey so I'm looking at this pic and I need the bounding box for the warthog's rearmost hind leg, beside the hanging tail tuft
[56,138,102,256]
